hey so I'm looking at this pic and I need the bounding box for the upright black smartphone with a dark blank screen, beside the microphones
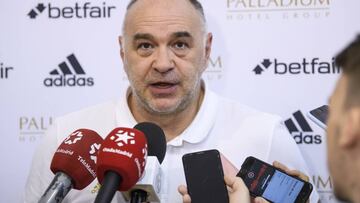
[182,149,229,203]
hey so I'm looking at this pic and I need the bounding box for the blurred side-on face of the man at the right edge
[327,75,351,200]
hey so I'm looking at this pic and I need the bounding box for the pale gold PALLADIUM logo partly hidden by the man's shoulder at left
[19,116,53,142]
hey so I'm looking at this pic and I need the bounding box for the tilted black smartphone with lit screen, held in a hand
[237,156,313,203]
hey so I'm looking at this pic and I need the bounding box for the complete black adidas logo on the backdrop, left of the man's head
[44,54,94,87]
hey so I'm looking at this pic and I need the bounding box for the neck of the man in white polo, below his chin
[128,87,205,142]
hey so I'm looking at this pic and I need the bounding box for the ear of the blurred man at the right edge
[339,107,360,148]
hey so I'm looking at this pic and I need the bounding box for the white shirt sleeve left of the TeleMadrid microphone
[23,124,57,203]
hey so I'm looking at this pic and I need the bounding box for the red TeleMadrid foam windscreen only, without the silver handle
[50,129,103,190]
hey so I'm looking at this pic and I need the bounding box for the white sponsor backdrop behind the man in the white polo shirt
[0,0,360,202]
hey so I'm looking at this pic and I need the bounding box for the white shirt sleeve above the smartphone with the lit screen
[267,123,319,203]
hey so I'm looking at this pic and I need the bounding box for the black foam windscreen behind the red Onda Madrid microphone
[134,122,166,164]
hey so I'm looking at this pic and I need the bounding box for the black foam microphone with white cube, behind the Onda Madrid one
[122,122,166,203]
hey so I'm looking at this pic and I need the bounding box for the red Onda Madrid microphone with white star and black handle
[95,128,147,203]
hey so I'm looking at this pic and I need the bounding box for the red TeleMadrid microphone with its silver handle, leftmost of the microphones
[39,129,103,203]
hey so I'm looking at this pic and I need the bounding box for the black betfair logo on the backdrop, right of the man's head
[252,57,340,75]
